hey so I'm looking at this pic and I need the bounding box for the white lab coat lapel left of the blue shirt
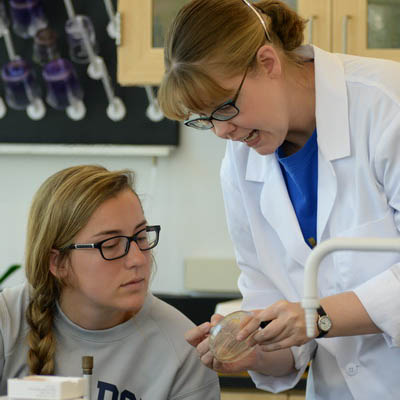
[246,151,311,265]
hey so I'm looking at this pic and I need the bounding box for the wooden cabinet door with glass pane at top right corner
[333,0,400,61]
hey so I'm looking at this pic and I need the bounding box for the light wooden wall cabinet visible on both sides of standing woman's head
[117,0,400,85]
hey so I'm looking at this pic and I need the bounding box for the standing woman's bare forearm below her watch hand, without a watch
[249,348,295,376]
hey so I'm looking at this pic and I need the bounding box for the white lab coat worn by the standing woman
[221,46,400,400]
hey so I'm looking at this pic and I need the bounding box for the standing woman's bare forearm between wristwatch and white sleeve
[321,292,381,337]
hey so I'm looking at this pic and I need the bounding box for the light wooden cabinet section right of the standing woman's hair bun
[297,0,400,61]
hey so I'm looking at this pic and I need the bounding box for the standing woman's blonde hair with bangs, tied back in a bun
[158,0,305,120]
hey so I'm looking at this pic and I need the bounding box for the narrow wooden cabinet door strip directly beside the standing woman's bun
[297,0,332,51]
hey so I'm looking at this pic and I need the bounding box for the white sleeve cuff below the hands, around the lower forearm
[248,340,317,393]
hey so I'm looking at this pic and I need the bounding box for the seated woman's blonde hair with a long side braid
[25,165,136,375]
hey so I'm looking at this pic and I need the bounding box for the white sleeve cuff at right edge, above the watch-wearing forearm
[354,264,400,347]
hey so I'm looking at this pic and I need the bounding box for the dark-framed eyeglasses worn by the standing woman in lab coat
[184,68,249,130]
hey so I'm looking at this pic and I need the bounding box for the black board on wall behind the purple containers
[0,0,179,146]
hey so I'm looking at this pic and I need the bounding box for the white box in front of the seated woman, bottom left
[7,375,85,400]
